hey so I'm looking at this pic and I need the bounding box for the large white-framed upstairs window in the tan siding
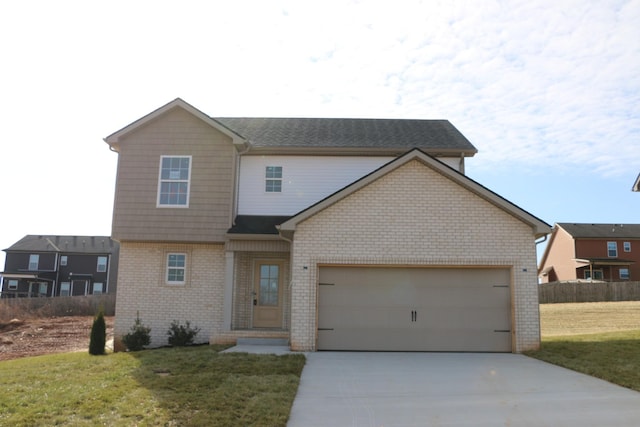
[158,156,191,207]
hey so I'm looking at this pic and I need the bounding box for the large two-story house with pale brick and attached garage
[105,99,550,352]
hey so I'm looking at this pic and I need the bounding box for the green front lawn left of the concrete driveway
[0,346,305,426]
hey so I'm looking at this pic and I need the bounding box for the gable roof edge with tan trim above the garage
[278,149,551,238]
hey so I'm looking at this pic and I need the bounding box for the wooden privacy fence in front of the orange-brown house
[538,282,640,304]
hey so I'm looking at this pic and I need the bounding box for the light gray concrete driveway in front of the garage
[288,352,640,427]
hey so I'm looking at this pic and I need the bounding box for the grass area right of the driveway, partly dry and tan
[526,301,640,391]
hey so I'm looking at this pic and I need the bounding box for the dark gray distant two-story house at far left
[0,235,119,298]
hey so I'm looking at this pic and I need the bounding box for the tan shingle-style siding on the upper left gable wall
[112,108,236,242]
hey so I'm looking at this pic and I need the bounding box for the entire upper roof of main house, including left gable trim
[104,98,477,157]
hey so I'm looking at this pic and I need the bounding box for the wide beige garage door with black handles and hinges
[318,267,511,352]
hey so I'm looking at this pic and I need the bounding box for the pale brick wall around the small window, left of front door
[114,242,225,347]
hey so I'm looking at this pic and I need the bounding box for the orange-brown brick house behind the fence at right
[538,223,640,283]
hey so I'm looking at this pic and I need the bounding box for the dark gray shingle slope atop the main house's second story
[213,117,477,155]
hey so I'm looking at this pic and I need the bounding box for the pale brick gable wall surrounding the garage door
[291,161,540,352]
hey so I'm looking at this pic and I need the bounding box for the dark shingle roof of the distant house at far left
[5,234,118,253]
